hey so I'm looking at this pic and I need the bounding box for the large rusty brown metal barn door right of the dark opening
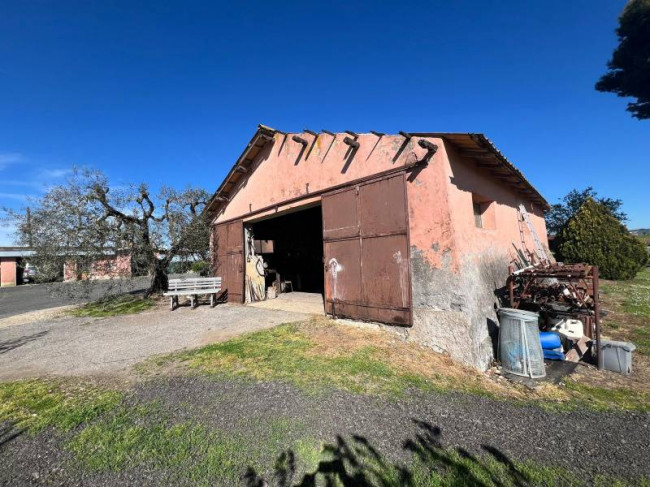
[322,174,411,325]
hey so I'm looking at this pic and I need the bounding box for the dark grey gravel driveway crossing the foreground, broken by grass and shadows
[0,377,650,486]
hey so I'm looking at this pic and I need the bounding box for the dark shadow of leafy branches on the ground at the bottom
[243,419,538,487]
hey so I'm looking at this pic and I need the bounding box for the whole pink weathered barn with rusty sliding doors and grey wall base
[207,125,549,368]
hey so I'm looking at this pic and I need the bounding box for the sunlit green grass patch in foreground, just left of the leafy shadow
[67,404,314,485]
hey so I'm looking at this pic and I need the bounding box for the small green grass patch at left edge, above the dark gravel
[0,379,121,432]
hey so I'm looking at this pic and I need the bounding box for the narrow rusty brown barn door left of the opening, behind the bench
[212,220,244,303]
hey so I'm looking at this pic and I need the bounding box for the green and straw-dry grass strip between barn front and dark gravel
[140,319,650,411]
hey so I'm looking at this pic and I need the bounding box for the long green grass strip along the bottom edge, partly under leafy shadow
[0,380,650,487]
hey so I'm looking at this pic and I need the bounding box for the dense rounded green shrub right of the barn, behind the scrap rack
[557,198,648,279]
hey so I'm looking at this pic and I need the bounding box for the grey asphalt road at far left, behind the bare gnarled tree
[0,277,148,319]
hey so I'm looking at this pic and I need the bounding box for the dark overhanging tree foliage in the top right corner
[596,0,650,120]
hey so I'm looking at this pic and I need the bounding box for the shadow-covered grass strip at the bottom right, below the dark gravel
[248,430,647,487]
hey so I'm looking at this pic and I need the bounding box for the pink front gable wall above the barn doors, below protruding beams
[216,133,426,223]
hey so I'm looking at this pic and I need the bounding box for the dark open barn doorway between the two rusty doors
[246,204,324,302]
